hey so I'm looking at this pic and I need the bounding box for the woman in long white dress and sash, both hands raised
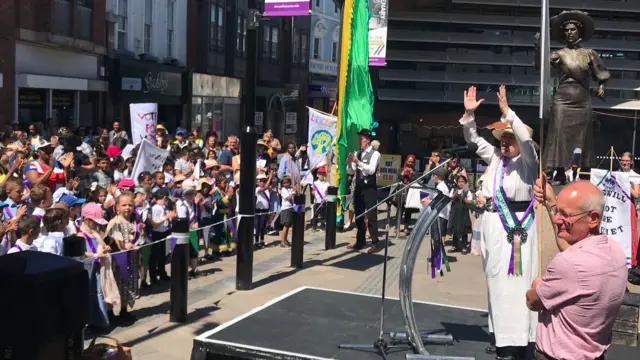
[460,86,538,360]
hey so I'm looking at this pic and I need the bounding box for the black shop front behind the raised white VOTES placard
[109,59,189,132]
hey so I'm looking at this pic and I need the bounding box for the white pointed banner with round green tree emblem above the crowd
[307,108,338,166]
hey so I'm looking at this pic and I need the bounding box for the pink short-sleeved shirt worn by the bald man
[536,235,627,360]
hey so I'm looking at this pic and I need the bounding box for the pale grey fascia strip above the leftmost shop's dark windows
[16,74,109,91]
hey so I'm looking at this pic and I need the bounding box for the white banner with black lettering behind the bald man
[591,169,637,267]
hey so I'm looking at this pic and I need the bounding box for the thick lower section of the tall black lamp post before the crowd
[236,126,256,290]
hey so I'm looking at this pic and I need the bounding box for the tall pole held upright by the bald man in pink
[536,0,551,276]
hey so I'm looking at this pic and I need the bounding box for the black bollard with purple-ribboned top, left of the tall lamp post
[167,233,191,323]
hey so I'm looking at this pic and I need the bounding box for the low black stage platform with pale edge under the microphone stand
[192,287,640,360]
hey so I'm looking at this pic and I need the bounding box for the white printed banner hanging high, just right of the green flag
[369,0,389,66]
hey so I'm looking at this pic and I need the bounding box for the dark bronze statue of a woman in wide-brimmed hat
[535,10,611,186]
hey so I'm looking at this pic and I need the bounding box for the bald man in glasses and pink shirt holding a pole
[526,180,627,360]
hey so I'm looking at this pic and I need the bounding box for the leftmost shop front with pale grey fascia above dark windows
[15,43,108,131]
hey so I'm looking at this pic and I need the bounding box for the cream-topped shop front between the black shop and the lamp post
[187,73,242,140]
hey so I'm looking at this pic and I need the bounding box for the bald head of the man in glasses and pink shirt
[553,181,604,245]
